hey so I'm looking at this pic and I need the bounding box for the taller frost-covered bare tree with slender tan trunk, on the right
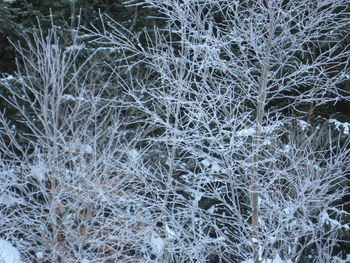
[89,0,350,263]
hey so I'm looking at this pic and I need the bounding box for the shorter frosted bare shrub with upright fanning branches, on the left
[0,26,155,263]
